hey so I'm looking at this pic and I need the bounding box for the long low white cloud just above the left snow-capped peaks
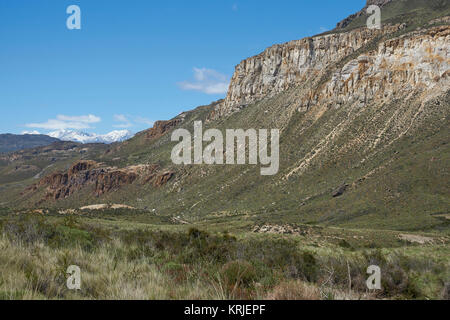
[25,114,101,130]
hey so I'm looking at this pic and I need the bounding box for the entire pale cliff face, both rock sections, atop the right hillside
[215,21,450,116]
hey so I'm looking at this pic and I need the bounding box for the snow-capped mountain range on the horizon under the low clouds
[47,130,134,143]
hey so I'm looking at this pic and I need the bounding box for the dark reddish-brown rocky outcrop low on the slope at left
[23,160,175,200]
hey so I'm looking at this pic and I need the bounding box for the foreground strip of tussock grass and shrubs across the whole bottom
[0,216,449,299]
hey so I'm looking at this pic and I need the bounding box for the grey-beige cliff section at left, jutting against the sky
[215,25,404,116]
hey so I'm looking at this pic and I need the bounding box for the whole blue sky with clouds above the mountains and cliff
[0,0,365,133]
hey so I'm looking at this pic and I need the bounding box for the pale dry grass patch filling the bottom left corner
[0,237,220,300]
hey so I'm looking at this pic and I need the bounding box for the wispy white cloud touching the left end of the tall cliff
[178,68,229,94]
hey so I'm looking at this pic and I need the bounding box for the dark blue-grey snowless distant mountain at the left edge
[0,133,59,152]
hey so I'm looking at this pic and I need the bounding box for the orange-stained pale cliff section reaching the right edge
[299,26,450,111]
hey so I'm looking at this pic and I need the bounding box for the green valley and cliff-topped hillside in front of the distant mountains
[0,0,450,300]
